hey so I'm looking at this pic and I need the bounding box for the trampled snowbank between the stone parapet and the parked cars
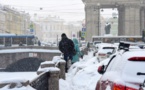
[59,52,109,90]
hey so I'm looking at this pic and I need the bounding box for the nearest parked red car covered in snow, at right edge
[96,46,145,90]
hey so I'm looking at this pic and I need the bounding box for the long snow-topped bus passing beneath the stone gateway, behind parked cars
[92,36,142,43]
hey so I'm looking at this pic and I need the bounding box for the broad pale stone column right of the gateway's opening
[125,5,140,36]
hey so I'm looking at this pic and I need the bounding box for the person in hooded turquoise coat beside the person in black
[72,38,82,64]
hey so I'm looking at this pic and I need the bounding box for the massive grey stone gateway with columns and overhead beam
[82,0,145,41]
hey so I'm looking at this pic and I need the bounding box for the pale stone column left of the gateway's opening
[85,5,100,41]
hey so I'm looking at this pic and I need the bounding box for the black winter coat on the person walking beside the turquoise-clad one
[59,37,74,55]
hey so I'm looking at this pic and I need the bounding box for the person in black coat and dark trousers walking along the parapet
[58,33,74,72]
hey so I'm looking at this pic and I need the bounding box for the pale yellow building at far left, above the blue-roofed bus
[1,6,30,35]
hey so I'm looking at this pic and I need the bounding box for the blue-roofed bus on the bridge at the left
[0,34,38,47]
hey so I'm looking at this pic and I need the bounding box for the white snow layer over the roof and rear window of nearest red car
[103,49,145,87]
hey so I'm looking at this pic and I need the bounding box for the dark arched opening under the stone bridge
[4,57,45,72]
